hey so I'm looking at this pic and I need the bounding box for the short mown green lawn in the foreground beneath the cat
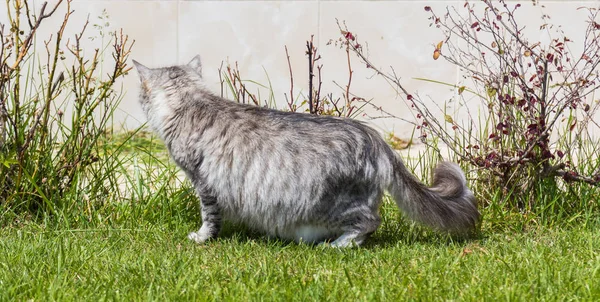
[0,214,600,301]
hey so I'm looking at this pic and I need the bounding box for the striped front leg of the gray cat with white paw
[188,195,222,243]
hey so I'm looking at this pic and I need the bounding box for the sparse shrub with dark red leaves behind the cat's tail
[338,0,600,214]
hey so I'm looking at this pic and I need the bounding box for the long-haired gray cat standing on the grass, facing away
[134,56,479,247]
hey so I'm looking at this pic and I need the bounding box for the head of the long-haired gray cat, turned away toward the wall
[133,56,202,134]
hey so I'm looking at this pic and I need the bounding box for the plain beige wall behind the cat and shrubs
[8,0,599,140]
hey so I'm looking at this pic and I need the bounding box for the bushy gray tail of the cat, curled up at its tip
[390,159,480,233]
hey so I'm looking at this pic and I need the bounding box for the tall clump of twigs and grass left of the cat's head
[0,0,133,224]
